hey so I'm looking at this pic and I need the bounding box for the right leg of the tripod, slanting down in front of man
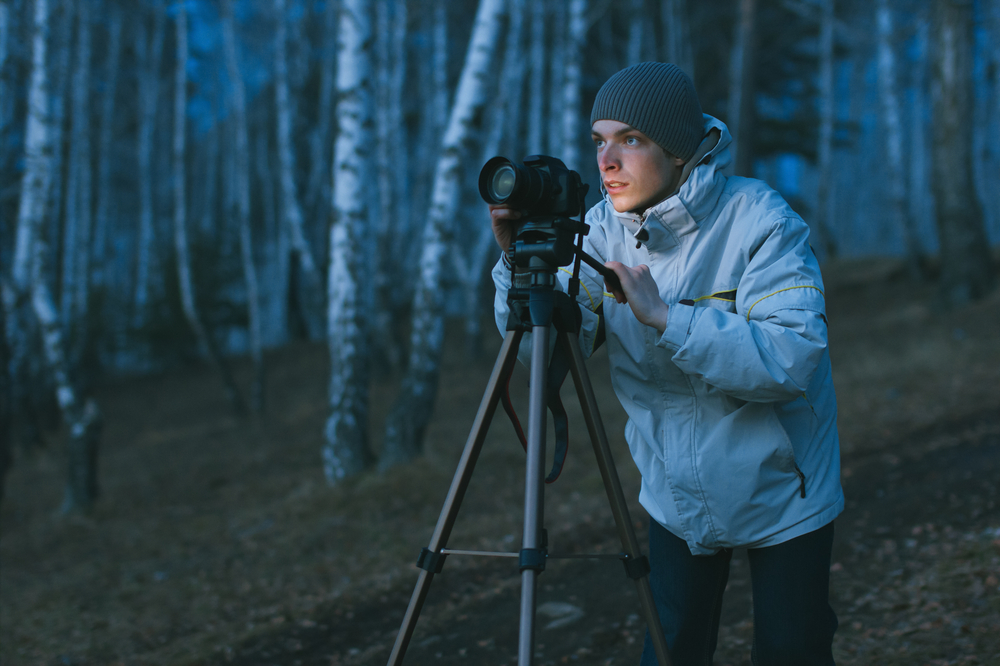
[559,332,670,666]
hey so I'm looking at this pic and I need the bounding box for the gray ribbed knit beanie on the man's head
[590,62,702,162]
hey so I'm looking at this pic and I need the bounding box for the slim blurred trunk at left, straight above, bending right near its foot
[171,3,243,412]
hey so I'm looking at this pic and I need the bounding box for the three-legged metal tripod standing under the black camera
[388,253,670,666]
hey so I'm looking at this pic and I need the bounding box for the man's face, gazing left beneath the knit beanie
[591,120,684,215]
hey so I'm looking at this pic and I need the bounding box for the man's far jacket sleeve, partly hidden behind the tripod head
[493,210,606,365]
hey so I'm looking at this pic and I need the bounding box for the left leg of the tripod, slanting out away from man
[388,331,523,666]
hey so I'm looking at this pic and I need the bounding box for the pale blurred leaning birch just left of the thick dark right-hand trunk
[875,0,922,280]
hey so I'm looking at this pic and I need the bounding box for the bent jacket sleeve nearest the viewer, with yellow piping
[657,217,827,402]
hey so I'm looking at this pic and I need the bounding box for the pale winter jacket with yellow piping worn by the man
[493,115,844,555]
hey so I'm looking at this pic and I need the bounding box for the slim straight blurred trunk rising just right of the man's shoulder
[816,0,837,259]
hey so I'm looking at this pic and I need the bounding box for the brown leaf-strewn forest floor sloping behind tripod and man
[0,255,1000,666]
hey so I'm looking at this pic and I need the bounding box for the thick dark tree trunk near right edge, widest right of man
[931,0,994,306]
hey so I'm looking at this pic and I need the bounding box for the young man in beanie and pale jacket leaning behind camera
[490,62,844,666]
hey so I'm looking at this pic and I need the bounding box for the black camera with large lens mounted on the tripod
[479,155,588,270]
